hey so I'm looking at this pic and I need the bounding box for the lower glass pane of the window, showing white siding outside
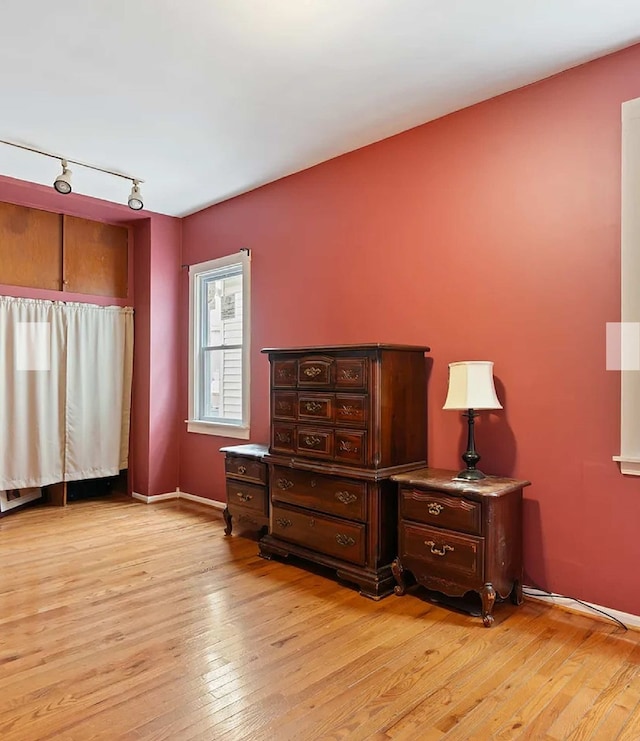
[202,348,242,423]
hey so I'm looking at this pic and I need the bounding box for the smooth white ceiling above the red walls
[0,0,640,216]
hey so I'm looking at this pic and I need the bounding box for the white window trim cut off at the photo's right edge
[613,98,640,476]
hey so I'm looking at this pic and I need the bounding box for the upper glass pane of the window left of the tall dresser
[203,273,242,347]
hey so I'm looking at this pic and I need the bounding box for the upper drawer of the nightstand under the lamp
[400,487,482,535]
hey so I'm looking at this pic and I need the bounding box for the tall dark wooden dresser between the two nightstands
[260,344,429,599]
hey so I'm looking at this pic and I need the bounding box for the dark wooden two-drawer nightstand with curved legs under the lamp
[392,468,530,627]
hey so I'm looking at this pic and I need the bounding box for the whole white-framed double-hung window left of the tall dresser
[187,250,251,440]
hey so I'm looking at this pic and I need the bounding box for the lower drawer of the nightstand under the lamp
[400,522,484,589]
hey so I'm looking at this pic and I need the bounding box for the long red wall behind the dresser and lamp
[180,46,640,614]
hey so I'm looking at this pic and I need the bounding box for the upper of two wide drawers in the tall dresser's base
[270,466,367,521]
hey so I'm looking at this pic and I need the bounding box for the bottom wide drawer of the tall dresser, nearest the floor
[270,504,366,565]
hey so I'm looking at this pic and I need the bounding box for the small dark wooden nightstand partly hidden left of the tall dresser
[220,444,269,535]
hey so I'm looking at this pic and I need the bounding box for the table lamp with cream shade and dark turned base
[442,360,502,481]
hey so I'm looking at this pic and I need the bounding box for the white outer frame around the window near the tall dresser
[187,249,251,440]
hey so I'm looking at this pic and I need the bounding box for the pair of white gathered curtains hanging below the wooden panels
[0,297,133,490]
